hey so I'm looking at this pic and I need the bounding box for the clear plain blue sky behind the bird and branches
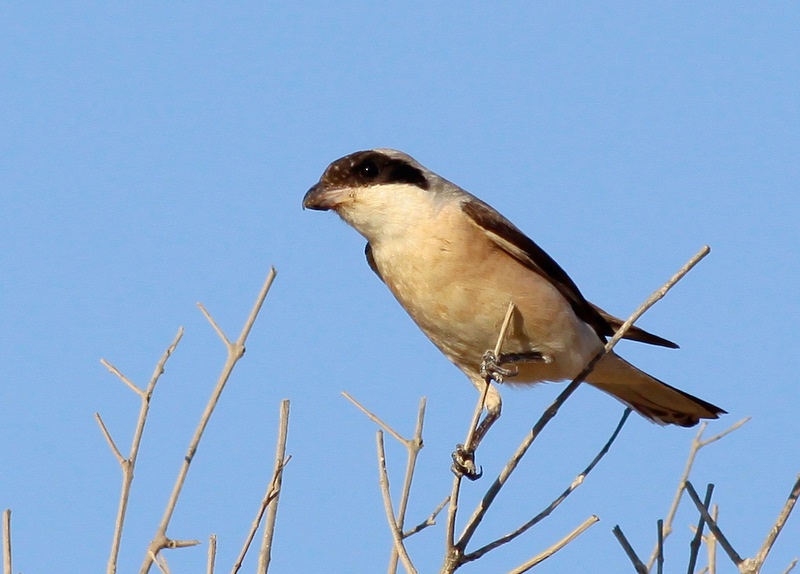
[0,1,800,573]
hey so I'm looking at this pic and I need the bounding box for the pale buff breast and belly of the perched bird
[372,202,599,382]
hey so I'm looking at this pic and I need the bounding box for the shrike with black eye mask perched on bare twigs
[303,149,725,436]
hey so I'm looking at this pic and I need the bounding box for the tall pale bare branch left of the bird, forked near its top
[139,267,277,574]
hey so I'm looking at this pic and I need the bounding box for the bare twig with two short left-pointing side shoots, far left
[94,327,183,574]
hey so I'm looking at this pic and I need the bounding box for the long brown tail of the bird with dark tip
[586,353,725,427]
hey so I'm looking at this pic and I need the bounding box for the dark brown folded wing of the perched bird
[461,197,677,348]
